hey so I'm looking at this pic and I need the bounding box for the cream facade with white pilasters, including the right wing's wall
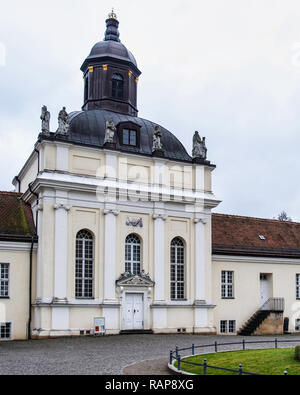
[3,141,300,338]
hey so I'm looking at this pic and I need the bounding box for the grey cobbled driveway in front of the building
[0,335,300,375]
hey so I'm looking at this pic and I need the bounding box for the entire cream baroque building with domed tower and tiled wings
[0,12,300,340]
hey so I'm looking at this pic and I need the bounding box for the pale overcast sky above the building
[0,0,300,221]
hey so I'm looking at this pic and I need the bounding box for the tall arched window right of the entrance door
[171,237,185,300]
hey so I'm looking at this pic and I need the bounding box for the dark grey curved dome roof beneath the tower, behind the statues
[63,110,192,162]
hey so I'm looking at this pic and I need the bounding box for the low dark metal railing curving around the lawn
[169,338,300,376]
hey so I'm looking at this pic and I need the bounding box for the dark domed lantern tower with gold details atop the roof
[81,11,141,117]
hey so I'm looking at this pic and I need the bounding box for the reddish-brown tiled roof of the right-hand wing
[212,214,300,258]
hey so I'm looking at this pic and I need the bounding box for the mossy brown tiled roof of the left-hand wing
[0,192,36,241]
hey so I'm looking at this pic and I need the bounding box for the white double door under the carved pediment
[125,293,144,330]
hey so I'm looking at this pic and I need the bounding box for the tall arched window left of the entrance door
[75,230,94,299]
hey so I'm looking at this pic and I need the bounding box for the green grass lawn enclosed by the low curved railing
[175,348,300,376]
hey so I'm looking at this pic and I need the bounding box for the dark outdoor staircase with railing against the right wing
[238,298,284,336]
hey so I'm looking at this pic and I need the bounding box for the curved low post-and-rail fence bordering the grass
[168,338,300,376]
